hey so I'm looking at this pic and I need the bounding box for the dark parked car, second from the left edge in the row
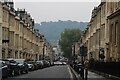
[3,59,20,76]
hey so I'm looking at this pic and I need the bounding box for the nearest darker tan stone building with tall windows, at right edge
[107,5,120,61]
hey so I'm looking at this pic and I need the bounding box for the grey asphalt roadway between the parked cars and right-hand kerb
[5,65,72,80]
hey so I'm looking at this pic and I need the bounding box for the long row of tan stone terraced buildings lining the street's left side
[0,2,52,60]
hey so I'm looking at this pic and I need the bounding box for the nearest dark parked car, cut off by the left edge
[0,61,8,78]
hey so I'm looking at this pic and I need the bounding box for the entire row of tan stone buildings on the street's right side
[82,1,120,61]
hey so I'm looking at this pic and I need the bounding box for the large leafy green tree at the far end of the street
[60,28,82,59]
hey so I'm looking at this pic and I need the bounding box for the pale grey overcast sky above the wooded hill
[15,0,100,23]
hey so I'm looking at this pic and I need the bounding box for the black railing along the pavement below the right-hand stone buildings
[90,62,120,77]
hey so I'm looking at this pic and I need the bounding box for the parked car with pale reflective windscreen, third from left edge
[14,59,29,74]
